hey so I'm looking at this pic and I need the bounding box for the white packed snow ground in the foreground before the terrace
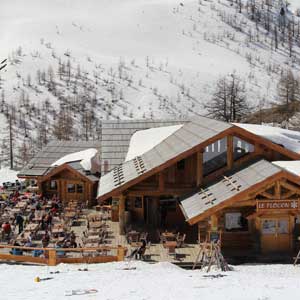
[0,262,300,300]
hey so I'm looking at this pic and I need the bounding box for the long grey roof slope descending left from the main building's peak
[98,116,233,198]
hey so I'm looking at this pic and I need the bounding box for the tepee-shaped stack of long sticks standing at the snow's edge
[193,242,231,272]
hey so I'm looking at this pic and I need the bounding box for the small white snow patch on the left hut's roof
[51,148,98,171]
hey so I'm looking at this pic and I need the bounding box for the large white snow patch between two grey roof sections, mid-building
[125,124,183,161]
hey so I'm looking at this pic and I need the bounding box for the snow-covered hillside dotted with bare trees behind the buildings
[0,0,300,169]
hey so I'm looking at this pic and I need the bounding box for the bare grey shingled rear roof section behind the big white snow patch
[101,119,187,174]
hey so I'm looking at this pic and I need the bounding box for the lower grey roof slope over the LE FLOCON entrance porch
[181,159,282,221]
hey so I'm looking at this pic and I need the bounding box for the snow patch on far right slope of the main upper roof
[234,123,300,153]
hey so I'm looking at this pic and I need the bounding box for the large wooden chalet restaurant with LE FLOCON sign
[98,117,300,257]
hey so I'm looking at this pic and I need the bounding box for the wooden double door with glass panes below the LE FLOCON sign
[261,216,291,253]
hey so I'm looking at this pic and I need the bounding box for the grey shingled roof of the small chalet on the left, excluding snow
[18,140,101,177]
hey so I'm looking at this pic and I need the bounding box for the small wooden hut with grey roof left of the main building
[18,141,100,207]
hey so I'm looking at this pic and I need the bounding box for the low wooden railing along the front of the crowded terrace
[0,245,127,266]
